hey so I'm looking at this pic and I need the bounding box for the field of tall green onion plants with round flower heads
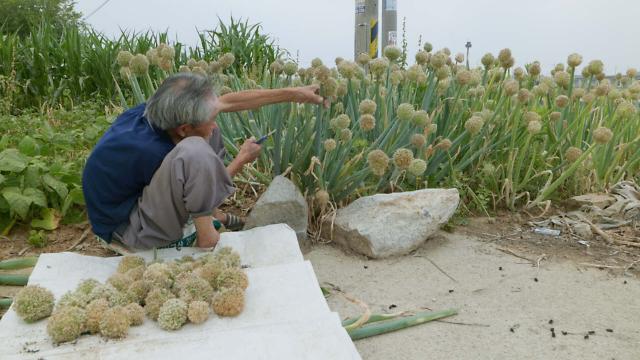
[117,44,640,213]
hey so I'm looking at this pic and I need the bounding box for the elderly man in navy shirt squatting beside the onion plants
[82,73,323,252]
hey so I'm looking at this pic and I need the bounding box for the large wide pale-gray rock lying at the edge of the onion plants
[323,189,460,258]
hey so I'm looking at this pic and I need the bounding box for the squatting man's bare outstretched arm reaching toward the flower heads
[217,85,324,112]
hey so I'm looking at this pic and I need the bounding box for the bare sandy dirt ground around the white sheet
[0,211,640,360]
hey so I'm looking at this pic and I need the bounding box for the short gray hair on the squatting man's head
[144,73,216,130]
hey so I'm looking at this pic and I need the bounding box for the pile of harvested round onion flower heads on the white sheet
[13,247,249,344]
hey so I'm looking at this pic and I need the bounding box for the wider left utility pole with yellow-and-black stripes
[353,0,379,59]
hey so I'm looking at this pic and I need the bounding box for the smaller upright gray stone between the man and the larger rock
[244,176,309,250]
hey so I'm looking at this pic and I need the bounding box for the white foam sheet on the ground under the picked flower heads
[0,225,360,360]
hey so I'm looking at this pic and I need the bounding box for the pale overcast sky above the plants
[76,0,640,75]
